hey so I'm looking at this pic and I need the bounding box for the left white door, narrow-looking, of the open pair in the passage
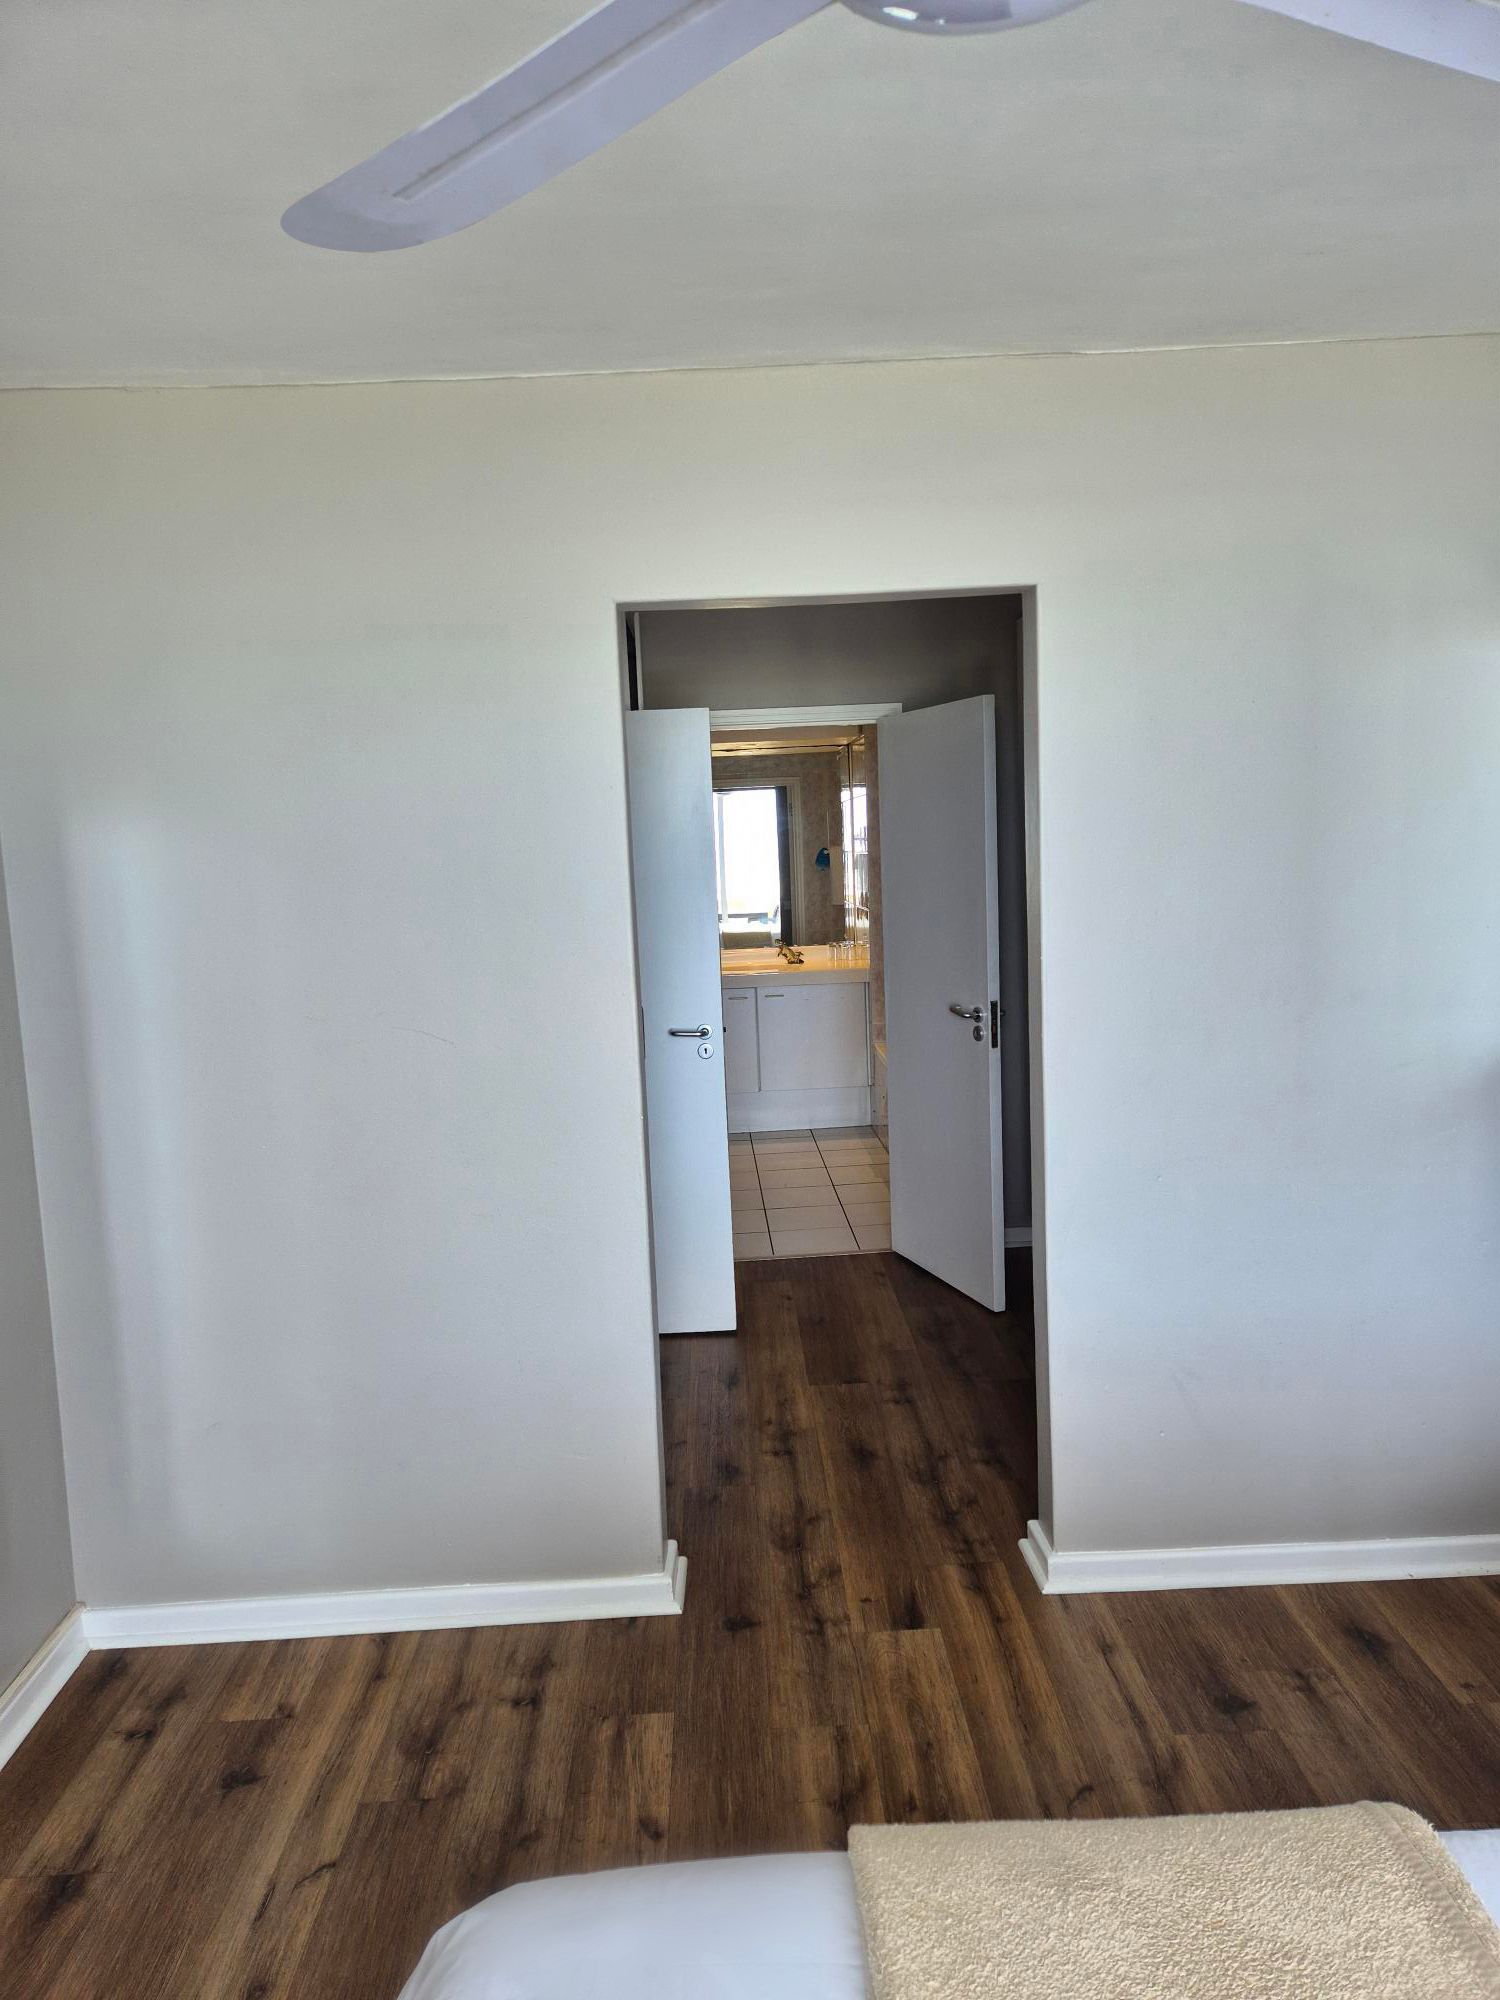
[626,708,734,1334]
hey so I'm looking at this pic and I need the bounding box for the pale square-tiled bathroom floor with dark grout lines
[730,1126,890,1258]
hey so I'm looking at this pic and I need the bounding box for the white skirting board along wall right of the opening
[1020,1520,1500,1596]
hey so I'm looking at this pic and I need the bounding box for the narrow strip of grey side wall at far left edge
[0,844,74,1688]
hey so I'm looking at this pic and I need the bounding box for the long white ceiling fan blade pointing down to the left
[282,0,828,250]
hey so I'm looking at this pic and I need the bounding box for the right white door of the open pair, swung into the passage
[876,694,1006,1310]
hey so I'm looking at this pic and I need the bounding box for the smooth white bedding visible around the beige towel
[400,1832,1500,2000]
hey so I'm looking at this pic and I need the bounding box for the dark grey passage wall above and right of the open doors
[640,596,1032,1228]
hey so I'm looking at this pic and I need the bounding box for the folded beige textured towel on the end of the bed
[848,1804,1500,2000]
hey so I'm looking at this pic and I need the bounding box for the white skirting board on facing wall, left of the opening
[82,1542,688,1646]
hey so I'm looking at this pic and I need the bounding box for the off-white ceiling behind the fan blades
[0,0,1500,384]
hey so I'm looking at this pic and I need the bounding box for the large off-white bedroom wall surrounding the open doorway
[0,340,1500,1600]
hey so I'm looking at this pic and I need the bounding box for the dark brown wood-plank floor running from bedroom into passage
[0,1256,1500,2000]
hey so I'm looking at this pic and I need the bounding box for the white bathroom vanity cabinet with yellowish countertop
[720,944,870,1132]
